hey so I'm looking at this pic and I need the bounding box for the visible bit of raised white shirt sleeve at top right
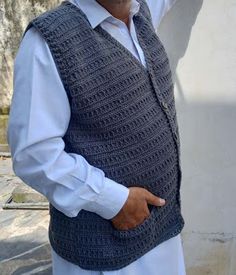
[146,0,177,30]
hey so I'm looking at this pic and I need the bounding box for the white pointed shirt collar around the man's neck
[70,0,140,29]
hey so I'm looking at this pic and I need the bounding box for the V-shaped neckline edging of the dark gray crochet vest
[62,0,149,74]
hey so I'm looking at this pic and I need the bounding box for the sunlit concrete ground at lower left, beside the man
[0,157,52,275]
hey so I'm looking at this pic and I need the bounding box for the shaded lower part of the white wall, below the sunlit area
[177,101,236,275]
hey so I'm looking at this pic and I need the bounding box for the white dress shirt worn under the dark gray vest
[7,0,185,275]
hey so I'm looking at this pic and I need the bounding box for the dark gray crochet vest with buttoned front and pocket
[22,0,184,271]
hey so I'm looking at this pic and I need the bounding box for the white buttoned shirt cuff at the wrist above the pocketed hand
[84,177,129,220]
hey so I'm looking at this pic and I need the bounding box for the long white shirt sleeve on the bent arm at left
[7,27,129,219]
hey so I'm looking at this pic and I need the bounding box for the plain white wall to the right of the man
[158,0,236,275]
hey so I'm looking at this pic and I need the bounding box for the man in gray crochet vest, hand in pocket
[8,0,185,275]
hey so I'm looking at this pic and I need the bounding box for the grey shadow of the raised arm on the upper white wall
[157,0,203,99]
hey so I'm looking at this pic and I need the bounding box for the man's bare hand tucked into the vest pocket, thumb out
[111,187,165,230]
